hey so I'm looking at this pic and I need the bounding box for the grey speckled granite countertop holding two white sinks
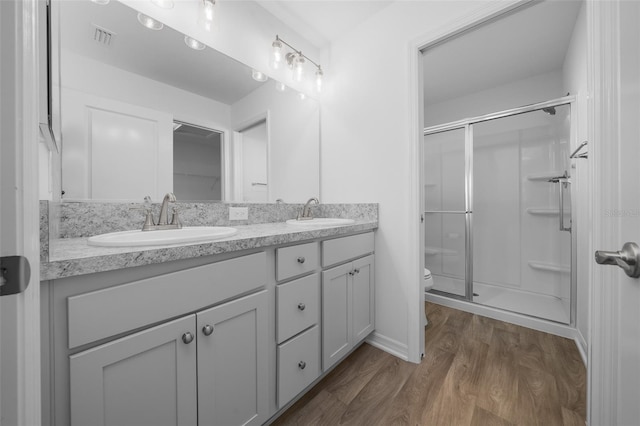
[40,220,378,281]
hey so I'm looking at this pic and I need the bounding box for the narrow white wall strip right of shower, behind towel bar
[563,5,592,353]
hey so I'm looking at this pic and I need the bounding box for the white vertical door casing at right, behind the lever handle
[587,0,622,425]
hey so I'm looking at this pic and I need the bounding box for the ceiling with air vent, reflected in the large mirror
[59,0,264,105]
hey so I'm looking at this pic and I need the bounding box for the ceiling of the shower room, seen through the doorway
[423,0,583,104]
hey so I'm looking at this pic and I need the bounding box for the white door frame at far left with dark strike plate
[0,0,45,425]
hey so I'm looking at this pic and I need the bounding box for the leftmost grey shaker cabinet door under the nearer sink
[69,315,198,426]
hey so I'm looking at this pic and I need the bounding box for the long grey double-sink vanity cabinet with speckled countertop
[41,205,377,426]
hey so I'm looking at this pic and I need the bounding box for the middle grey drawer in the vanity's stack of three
[276,274,320,343]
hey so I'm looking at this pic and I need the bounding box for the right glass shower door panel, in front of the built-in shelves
[472,104,571,324]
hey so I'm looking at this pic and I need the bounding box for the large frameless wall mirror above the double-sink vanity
[52,0,320,203]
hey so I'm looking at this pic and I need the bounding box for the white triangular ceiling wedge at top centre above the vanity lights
[256,0,395,48]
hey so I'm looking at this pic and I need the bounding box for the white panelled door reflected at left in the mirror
[62,88,173,200]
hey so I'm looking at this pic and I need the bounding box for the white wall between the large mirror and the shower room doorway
[321,1,508,360]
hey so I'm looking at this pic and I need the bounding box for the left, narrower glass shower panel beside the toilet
[422,127,471,299]
